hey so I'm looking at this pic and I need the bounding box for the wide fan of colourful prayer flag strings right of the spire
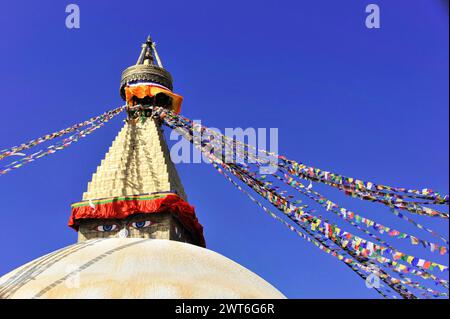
[153,108,449,298]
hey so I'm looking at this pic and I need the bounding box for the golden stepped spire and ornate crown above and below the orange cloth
[83,36,186,200]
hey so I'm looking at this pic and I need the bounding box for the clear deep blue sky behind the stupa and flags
[0,0,449,298]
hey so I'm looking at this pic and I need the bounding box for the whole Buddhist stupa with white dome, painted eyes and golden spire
[0,37,285,298]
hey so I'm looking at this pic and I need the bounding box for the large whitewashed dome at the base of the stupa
[0,238,285,298]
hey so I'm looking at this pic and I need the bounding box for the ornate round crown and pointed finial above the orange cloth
[120,36,173,100]
